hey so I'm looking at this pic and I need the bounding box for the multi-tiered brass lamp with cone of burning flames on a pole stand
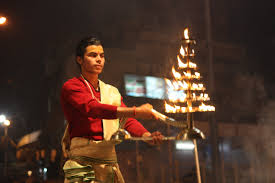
[165,29,215,183]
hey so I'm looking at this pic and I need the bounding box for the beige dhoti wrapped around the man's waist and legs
[63,137,124,183]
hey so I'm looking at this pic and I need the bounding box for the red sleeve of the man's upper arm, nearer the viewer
[61,80,117,119]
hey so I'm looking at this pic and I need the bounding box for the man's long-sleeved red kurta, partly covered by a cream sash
[61,77,147,140]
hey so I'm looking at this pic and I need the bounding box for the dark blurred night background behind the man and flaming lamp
[0,0,275,183]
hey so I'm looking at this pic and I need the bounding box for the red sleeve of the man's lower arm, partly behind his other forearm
[121,97,148,137]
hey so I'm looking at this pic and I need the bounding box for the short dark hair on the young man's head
[76,36,102,58]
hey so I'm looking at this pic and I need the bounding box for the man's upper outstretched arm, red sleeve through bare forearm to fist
[61,81,157,119]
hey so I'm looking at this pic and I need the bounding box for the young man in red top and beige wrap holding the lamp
[61,37,162,183]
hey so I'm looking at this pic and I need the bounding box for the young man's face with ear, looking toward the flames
[77,45,105,74]
